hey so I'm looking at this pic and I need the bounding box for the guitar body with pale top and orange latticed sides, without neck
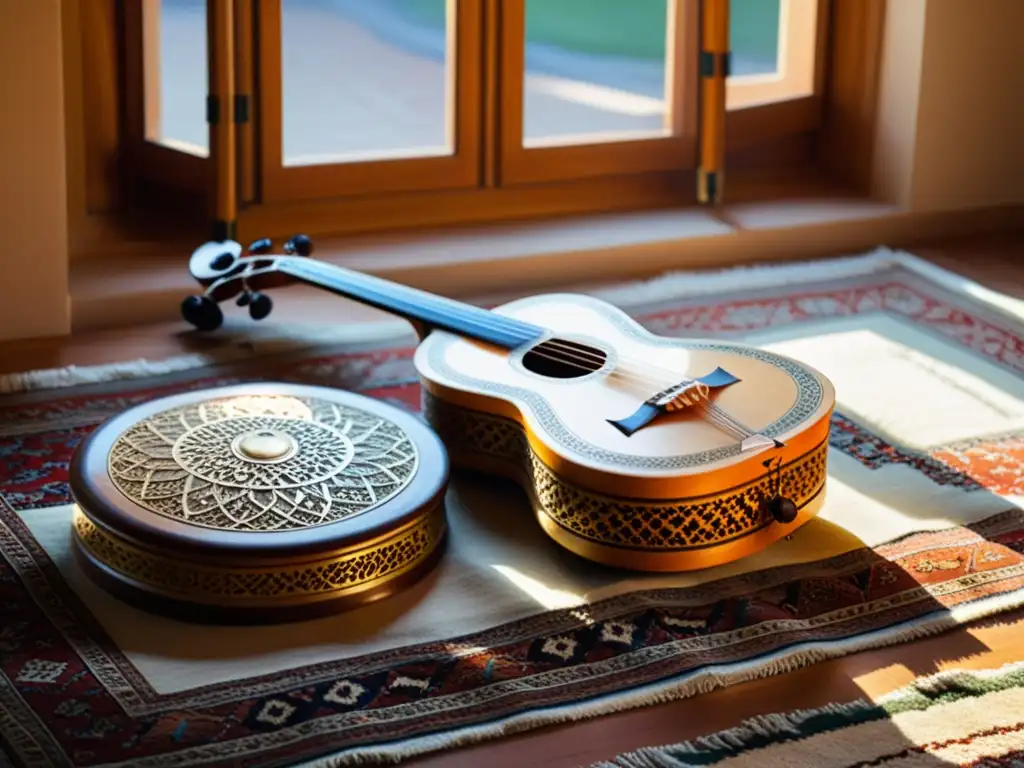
[415,294,835,571]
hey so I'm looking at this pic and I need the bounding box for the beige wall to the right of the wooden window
[873,0,1024,211]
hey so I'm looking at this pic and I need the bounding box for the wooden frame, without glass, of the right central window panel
[499,0,699,186]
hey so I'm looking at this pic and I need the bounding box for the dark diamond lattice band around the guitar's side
[424,393,828,552]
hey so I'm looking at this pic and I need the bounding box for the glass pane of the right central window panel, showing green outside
[522,0,670,146]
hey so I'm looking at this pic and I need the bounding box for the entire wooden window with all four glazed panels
[74,0,884,246]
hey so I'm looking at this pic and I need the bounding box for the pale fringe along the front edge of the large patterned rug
[288,590,1024,768]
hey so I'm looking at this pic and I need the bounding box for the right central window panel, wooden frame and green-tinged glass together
[497,0,698,184]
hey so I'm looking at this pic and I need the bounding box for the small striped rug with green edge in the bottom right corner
[592,664,1024,768]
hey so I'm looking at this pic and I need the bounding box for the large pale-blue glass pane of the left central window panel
[281,0,454,166]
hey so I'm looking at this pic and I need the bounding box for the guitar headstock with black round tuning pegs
[181,234,313,331]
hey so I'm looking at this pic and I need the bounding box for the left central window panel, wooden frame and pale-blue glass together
[257,0,482,203]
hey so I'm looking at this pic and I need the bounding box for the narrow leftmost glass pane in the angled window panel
[145,0,210,158]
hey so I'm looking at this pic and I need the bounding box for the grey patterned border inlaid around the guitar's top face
[427,296,824,469]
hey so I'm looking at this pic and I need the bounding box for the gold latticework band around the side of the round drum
[74,507,444,606]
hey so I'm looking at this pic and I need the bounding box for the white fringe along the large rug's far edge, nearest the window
[6,246,1024,394]
